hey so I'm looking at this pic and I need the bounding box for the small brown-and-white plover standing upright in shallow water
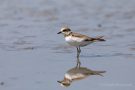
[57,27,105,58]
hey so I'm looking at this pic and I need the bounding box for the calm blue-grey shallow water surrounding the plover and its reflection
[0,0,135,90]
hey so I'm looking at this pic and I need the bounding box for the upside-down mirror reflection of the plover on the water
[58,58,105,87]
